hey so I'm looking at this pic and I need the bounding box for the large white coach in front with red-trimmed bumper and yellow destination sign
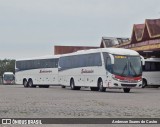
[58,48,142,93]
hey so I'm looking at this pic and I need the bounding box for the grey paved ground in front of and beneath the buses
[0,85,160,118]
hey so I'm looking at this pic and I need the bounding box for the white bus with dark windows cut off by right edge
[142,58,160,87]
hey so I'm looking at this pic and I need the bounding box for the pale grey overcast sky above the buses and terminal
[0,0,160,59]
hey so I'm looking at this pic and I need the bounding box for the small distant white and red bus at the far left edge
[3,72,15,85]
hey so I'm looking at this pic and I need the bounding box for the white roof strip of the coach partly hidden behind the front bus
[16,55,60,61]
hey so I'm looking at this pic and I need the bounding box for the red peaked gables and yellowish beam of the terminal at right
[113,19,160,57]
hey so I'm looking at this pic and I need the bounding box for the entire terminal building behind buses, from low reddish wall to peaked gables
[54,19,160,57]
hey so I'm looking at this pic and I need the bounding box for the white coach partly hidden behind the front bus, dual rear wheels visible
[15,56,59,88]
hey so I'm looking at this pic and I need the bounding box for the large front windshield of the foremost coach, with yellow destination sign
[112,55,142,77]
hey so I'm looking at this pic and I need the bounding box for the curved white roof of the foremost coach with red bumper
[59,48,139,56]
